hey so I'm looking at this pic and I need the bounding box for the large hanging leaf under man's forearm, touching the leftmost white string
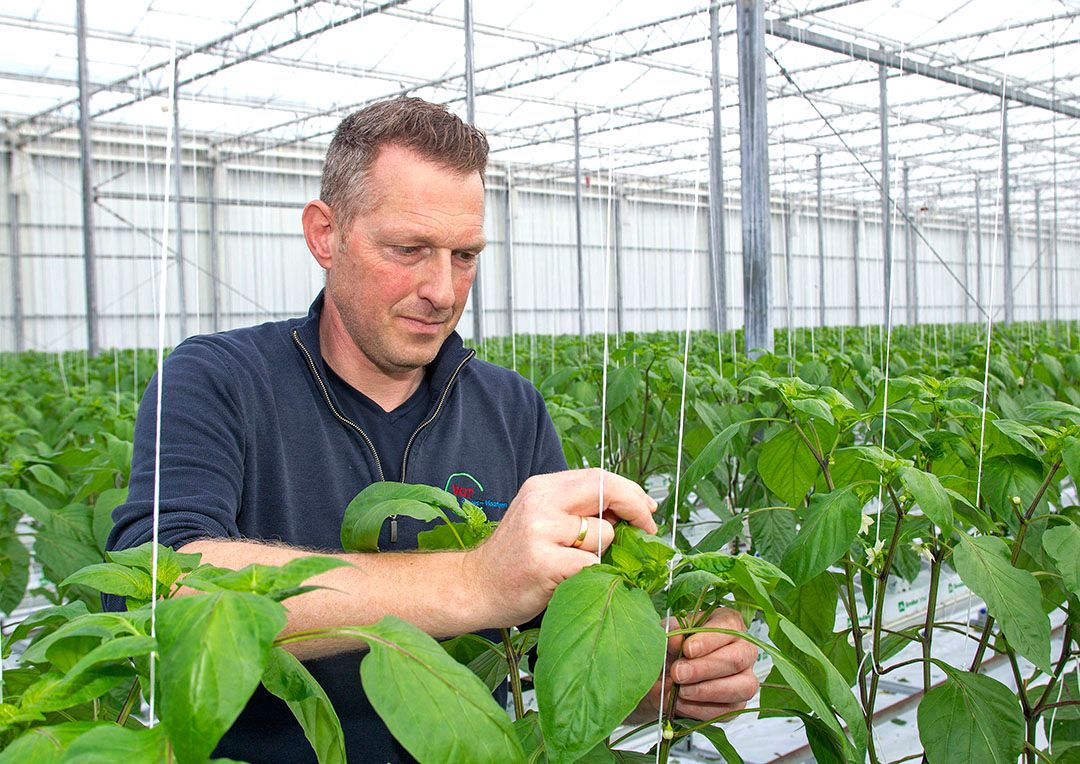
[158,591,285,764]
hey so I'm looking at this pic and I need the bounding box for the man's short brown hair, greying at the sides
[319,97,488,230]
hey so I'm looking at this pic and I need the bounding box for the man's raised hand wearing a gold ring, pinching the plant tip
[463,469,657,627]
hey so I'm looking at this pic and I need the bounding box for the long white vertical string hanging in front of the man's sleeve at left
[149,37,176,727]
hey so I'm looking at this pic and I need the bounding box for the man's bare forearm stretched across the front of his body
[180,539,496,660]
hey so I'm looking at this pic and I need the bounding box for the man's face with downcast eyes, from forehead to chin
[326,146,485,374]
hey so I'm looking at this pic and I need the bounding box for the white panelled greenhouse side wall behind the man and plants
[0,135,1080,351]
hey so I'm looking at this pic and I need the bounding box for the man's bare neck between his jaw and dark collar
[319,299,424,412]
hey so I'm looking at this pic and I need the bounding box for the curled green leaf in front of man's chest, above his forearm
[341,482,458,552]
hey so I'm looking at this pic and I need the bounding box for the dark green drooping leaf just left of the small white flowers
[781,488,863,586]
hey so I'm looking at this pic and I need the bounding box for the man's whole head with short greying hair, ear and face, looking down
[303,98,487,379]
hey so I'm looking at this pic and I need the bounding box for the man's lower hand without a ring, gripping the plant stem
[634,607,758,722]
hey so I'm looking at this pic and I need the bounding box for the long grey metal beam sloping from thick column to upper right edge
[765,21,1080,118]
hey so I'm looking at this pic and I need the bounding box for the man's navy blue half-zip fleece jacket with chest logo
[108,295,566,762]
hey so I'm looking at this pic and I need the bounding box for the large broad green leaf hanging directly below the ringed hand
[535,565,666,764]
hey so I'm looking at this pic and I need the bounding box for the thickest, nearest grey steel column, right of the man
[735,0,772,357]
